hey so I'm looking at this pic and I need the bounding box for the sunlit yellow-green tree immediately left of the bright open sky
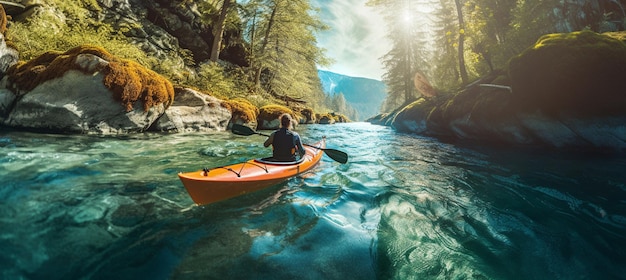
[244,0,326,104]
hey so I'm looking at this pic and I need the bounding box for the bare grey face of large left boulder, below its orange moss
[4,70,165,134]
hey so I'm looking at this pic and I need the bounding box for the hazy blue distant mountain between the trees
[317,70,387,121]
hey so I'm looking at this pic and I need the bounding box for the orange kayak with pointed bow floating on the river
[178,139,326,205]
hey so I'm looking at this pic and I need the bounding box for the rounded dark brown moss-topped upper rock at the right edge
[509,31,626,116]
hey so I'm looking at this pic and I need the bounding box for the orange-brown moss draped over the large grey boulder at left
[8,45,174,111]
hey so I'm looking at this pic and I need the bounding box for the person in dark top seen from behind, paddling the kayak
[263,113,305,162]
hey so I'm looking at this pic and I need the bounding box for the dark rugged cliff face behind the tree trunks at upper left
[90,0,248,66]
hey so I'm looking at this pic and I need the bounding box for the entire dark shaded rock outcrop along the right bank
[380,32,626,151]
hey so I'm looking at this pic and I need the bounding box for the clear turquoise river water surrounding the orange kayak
[0,123,626,279]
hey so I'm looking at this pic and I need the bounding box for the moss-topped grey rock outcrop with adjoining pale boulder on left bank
[0,41,230,135]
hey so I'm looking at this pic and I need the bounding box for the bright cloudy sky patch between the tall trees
[311,0,390,80]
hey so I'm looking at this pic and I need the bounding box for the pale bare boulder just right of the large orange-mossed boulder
[150,88,231,132]
